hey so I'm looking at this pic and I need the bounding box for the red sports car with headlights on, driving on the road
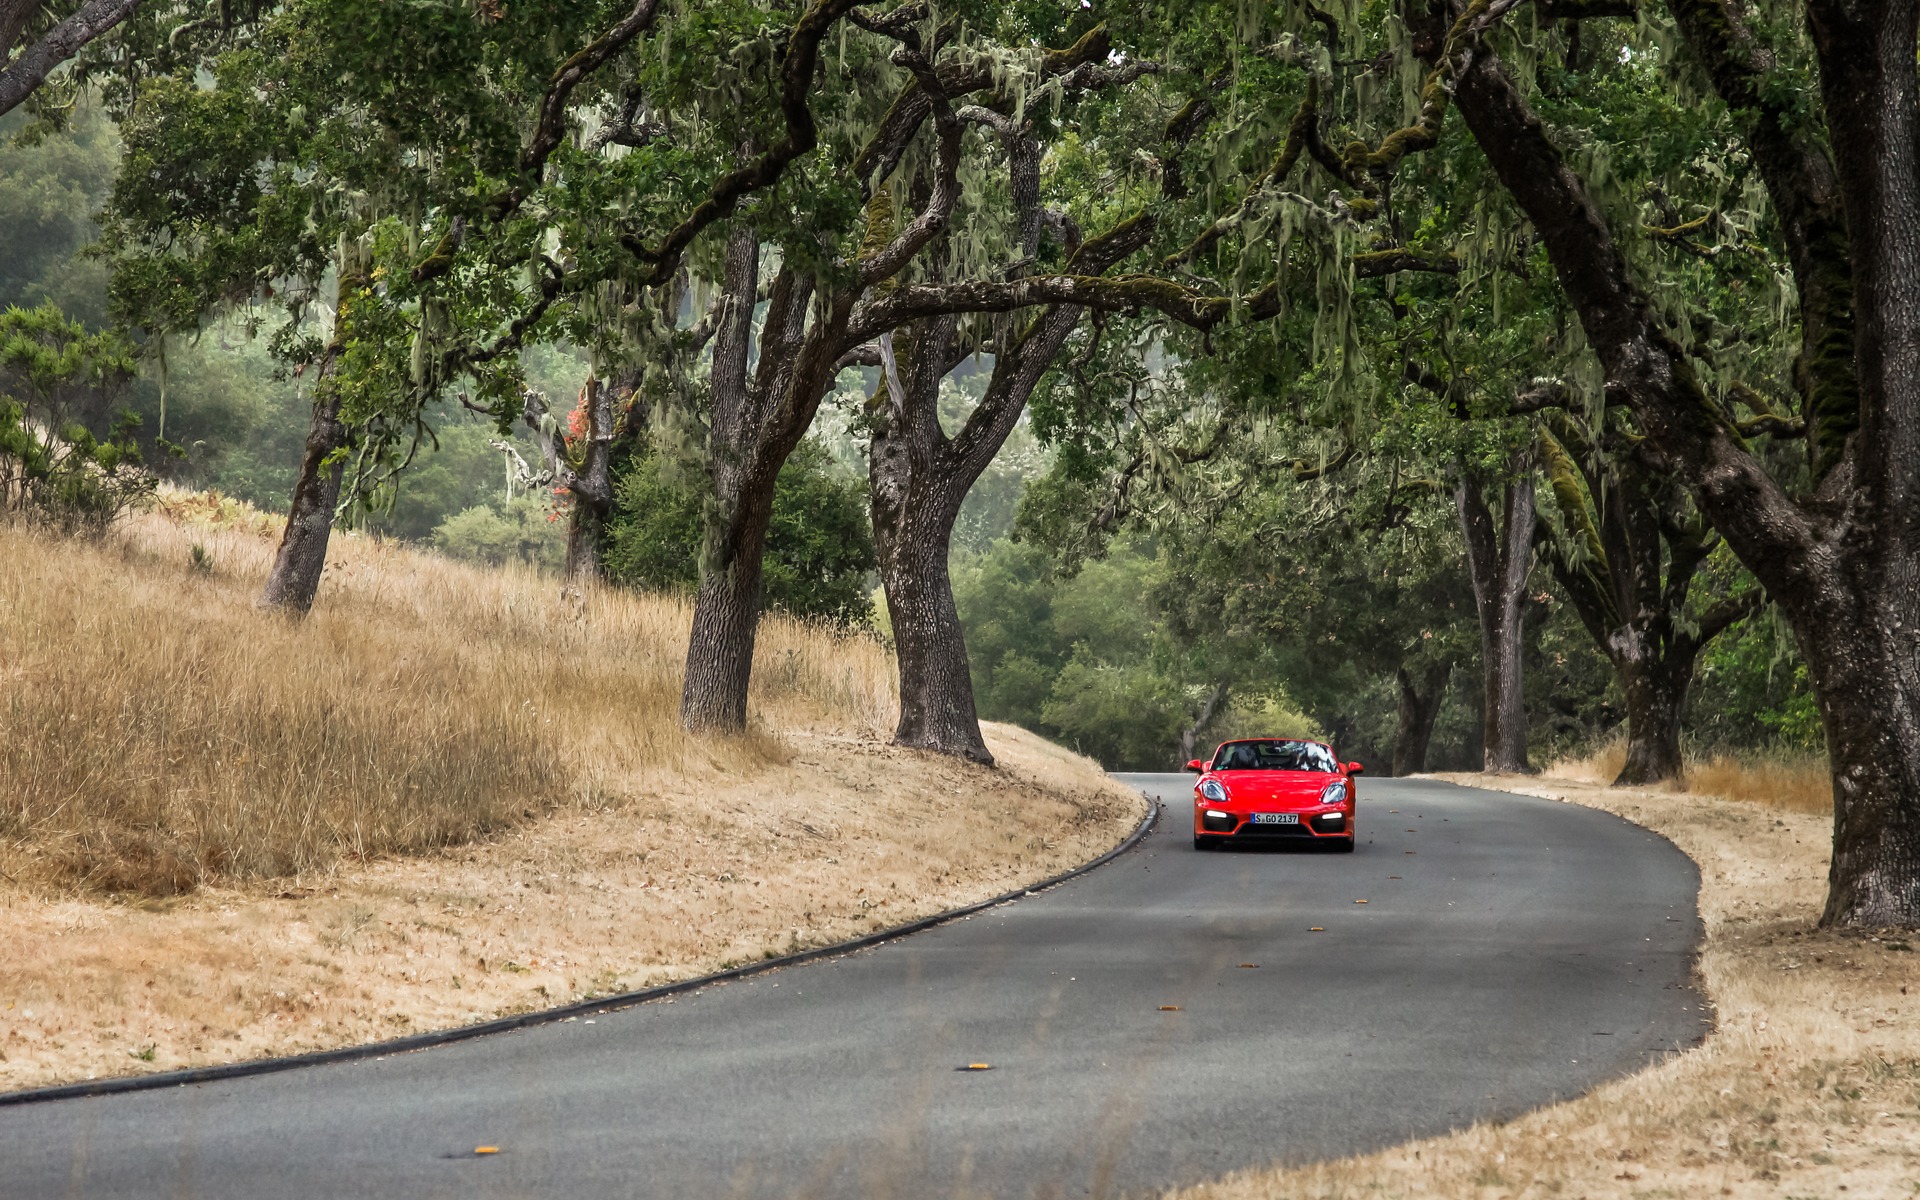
[1187,737,1363,852]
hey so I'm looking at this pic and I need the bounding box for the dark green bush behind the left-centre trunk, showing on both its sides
[605,440,877,624]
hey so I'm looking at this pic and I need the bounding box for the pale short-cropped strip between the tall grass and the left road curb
[0,726,1144,1091]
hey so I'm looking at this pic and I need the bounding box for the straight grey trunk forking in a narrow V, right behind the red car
[1453,472,1534,774]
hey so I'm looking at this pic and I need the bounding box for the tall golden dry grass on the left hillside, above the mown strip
[0,487,893,895]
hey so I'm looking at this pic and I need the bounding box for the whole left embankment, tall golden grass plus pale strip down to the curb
[0,497,1142,1091]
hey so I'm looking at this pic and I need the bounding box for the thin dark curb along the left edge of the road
[0,789,1162,1108]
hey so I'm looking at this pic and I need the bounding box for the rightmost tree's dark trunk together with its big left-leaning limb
[1455,32,1920,927]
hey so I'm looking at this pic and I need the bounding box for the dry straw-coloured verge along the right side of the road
[1181,755,1920,1200]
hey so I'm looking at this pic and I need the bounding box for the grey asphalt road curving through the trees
[0,776,1707,1200]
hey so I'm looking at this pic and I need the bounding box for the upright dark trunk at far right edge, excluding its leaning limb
[1780,0,1920,927]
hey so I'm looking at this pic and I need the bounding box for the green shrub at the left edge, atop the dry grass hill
[0,303,143,532]
